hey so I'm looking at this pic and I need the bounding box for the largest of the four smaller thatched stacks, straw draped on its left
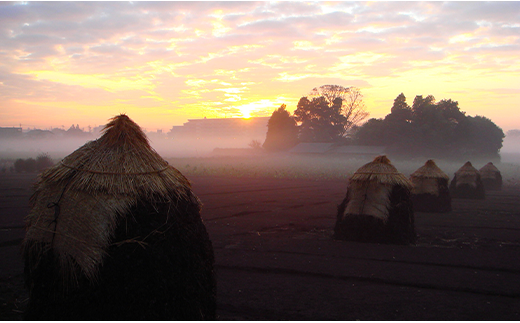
[334,156,416,244]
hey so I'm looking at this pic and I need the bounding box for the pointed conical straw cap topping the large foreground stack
[38,114,190,199]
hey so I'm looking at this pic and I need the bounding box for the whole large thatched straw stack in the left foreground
[23,115,216,320]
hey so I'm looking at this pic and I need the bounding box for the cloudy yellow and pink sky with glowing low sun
[0,1,520,132]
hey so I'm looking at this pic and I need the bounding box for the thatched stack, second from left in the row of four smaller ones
[410,159,451,212]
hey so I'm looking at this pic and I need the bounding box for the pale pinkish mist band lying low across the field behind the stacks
[0,132,520,185]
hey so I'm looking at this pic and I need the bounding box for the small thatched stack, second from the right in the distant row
[450,161,486,199]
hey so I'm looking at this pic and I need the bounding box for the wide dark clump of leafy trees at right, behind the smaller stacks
[355,93,504,158]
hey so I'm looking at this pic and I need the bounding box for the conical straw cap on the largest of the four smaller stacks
[350,155,412,189]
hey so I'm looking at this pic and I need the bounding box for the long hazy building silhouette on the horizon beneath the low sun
[168,117,270,140]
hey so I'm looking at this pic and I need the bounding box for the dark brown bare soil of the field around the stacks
[0,174,520,321]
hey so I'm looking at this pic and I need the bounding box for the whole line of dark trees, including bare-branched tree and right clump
[263,85,505,157]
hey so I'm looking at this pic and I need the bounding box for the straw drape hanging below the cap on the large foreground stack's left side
[25,185,130,288]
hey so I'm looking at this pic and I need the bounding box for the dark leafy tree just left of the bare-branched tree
[294,96,346,142]
